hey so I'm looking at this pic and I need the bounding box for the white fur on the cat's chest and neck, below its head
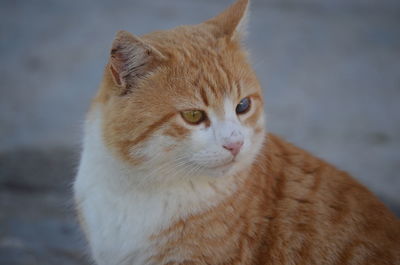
[74,110,235,265]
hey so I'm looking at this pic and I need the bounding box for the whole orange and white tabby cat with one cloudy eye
[74,0,400,265]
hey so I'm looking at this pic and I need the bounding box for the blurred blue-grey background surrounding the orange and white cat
[0,0,400,265]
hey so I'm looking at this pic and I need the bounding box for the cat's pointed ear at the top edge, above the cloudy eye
[205,0,250,40]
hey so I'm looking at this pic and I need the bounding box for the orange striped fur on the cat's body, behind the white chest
[148,134,400,265]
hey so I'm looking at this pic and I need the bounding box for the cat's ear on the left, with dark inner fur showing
[108,30,165,93]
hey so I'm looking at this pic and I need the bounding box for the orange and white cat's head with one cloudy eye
[95,0,264,183]
